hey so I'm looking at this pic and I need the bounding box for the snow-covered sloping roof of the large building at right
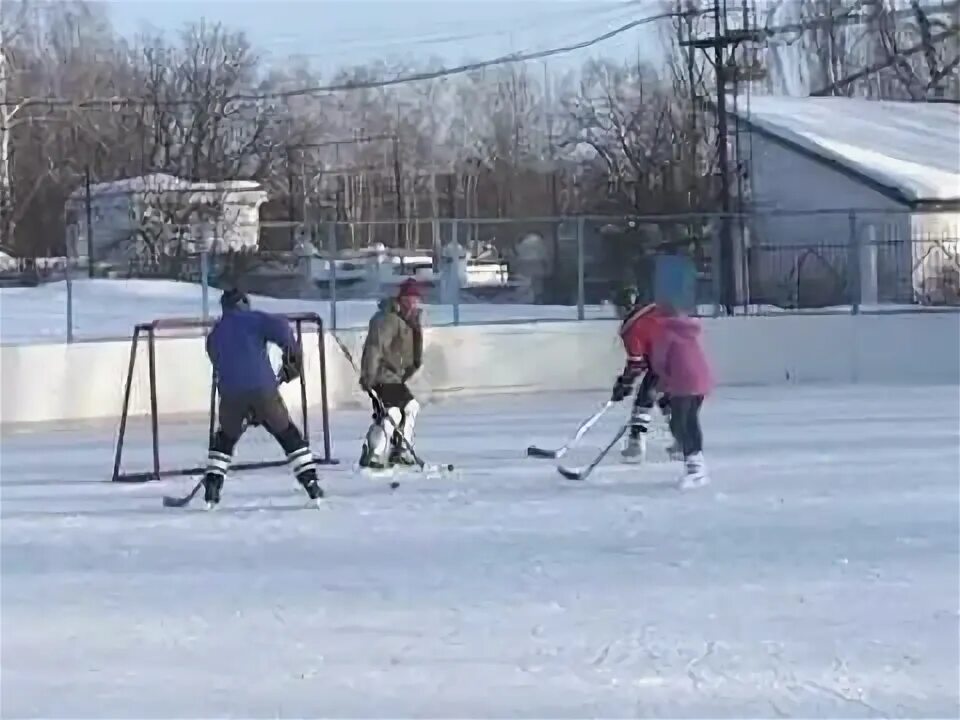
[737,95,960,203]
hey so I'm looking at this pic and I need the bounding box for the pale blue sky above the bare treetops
[97,0,663,74]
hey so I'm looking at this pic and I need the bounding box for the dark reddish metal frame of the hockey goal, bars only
[112,313,339,483]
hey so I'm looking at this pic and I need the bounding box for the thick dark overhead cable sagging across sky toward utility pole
[0,10,688,109]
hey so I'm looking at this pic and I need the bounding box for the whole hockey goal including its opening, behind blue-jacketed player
[112,313,338,483]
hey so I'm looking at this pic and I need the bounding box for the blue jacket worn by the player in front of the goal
[207,310,296,394]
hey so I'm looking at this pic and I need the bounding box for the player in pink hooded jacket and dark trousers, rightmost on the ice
[650,310,714,487]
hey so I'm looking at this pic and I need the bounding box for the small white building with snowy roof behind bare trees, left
[65,173,267,262]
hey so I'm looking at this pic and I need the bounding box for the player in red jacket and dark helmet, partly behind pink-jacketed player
[610,287,672,462]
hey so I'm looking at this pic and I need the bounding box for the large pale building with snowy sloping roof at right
[731,96,960,305]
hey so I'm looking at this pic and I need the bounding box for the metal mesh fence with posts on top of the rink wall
[0,210,960,342]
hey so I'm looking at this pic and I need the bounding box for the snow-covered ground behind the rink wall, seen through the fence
[0,279,614,343]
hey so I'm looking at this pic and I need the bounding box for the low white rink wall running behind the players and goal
[0,313,960,425]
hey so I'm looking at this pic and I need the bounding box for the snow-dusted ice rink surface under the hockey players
[0,386,960,718]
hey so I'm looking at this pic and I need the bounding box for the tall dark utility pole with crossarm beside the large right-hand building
[680,0,761,314]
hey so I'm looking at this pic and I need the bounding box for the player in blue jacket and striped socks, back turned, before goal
[203,290,323,508]
